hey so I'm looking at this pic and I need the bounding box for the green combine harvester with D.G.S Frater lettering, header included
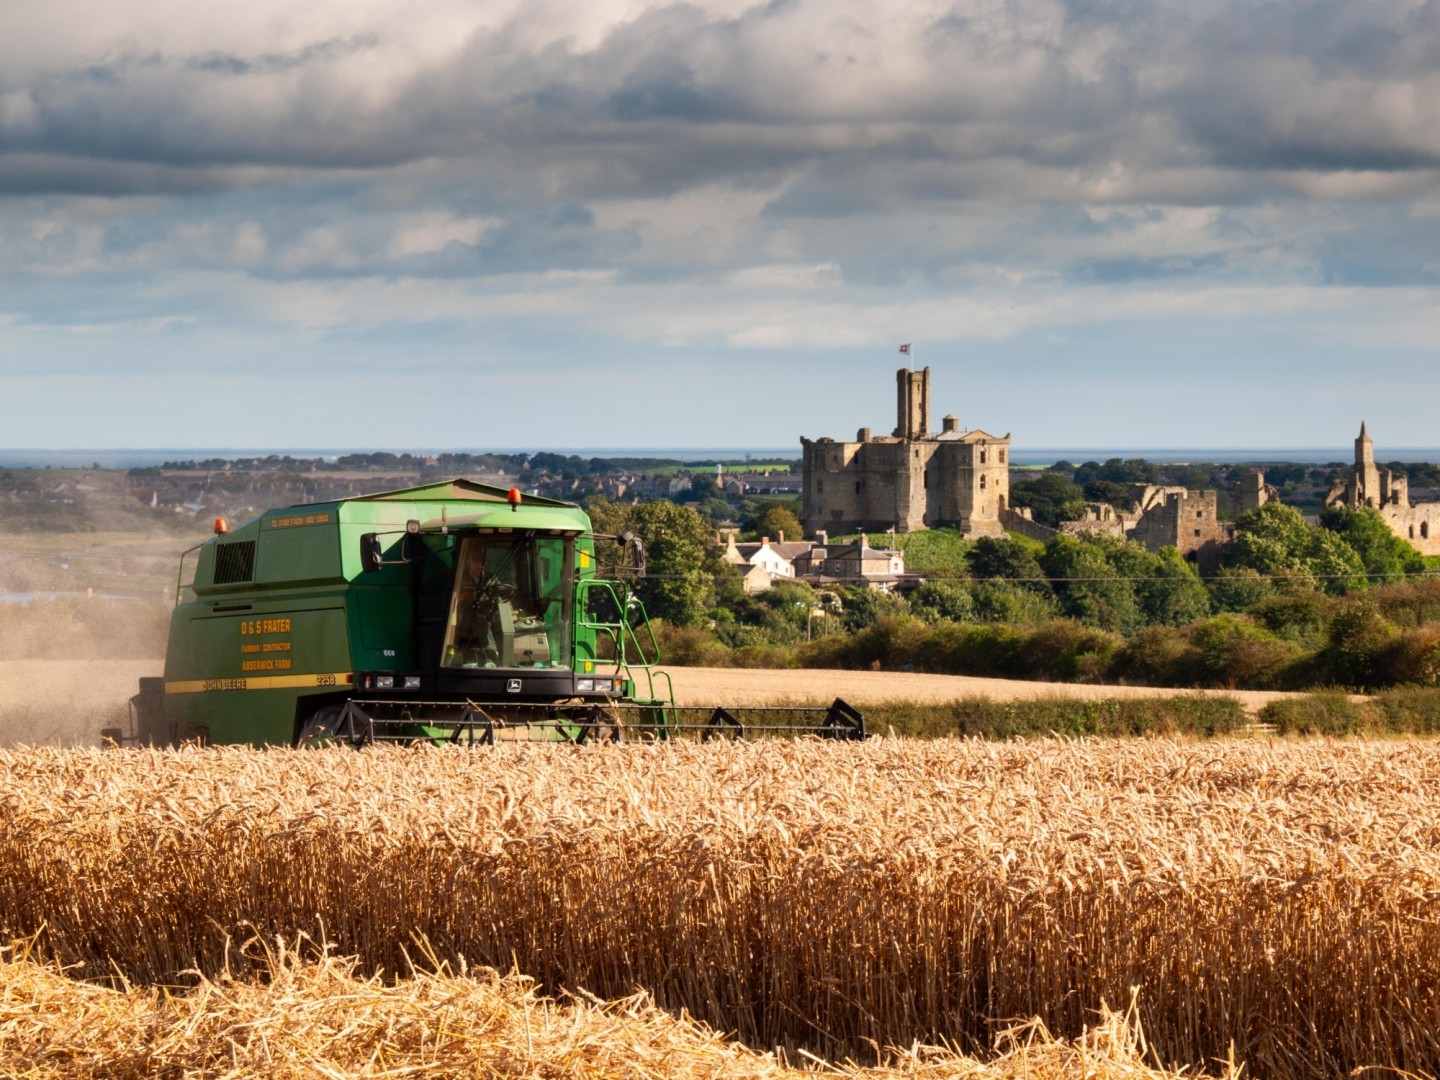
[123,480,864,746]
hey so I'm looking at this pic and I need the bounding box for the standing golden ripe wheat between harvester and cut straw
[0,739,1440,1077]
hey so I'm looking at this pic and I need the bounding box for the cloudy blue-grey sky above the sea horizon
[0,0,1440,458]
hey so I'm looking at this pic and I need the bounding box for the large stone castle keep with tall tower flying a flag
[801,367,1009,536]
